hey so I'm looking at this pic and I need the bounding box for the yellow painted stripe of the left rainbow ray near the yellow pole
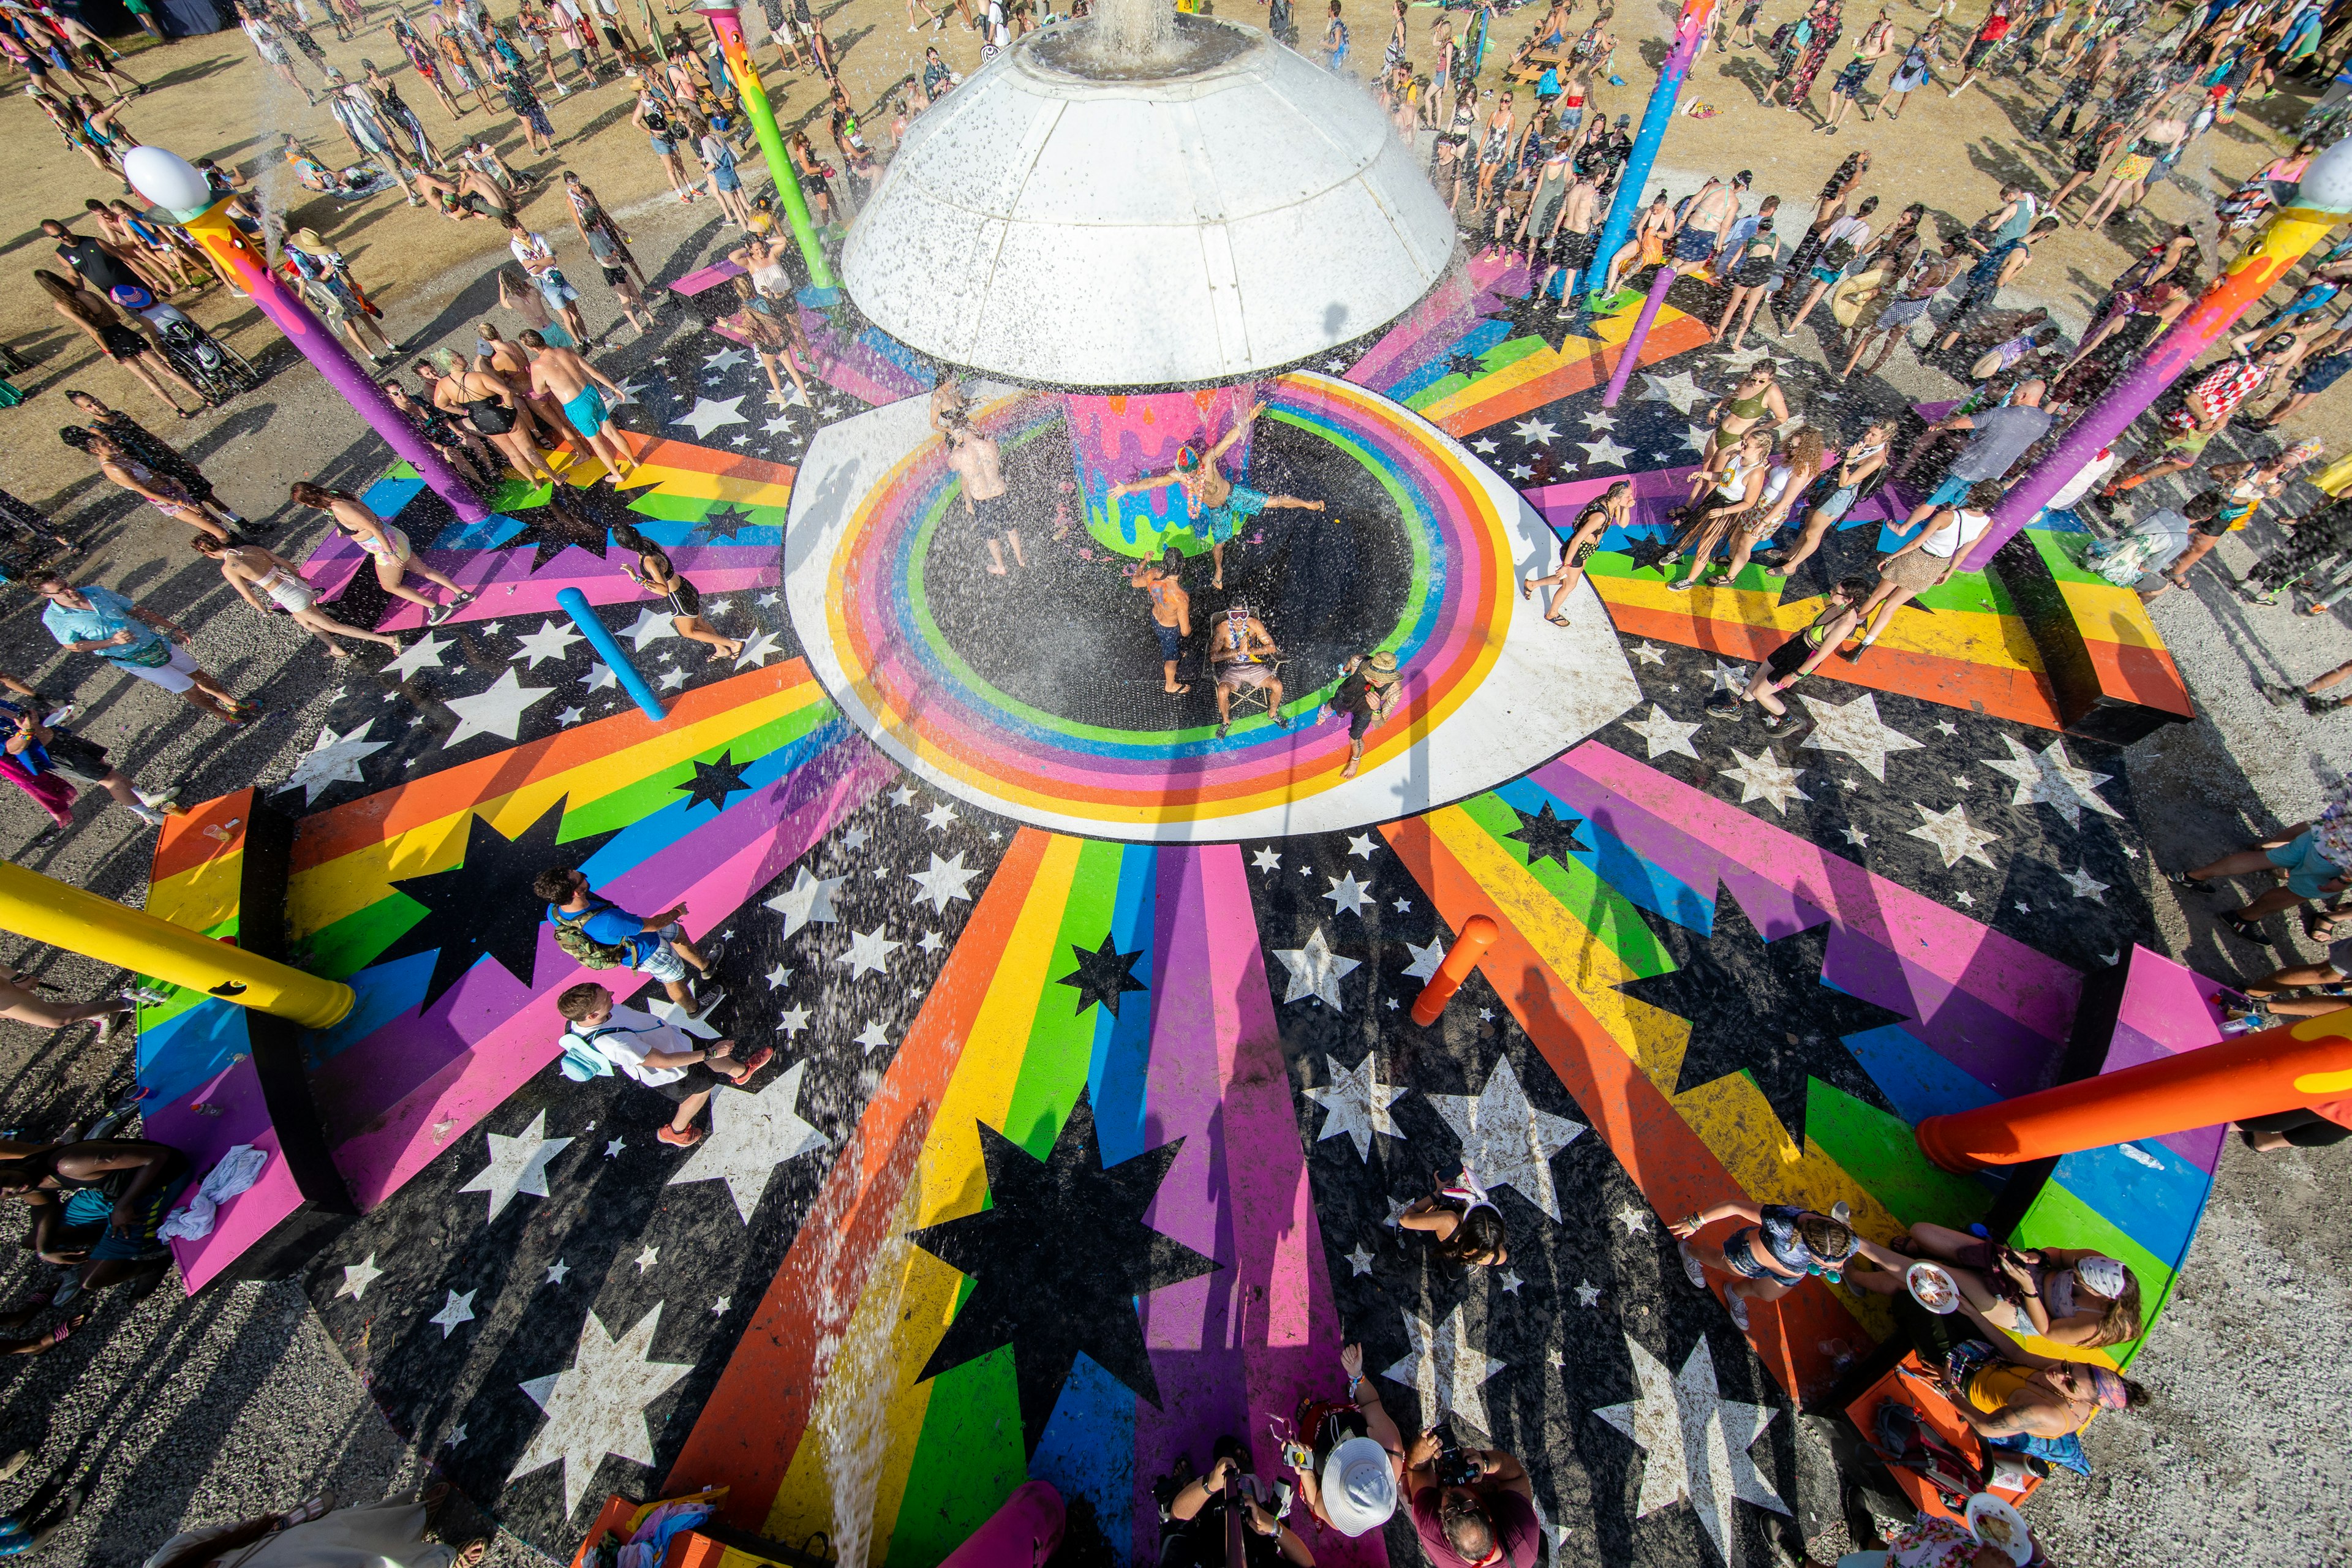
[287,682,826,936]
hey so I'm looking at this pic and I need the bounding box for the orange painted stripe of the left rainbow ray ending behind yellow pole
[294,658,809,872]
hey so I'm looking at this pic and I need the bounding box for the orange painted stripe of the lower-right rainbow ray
[1381,818,1870,1399]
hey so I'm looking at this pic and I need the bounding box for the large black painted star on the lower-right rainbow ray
[1618,889,1903,1150]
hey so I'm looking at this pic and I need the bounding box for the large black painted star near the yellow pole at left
[374,797,614,1013]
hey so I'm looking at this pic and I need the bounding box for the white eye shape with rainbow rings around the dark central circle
[783,374,1637,842]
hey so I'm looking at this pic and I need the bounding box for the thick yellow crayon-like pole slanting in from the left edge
[0,865,353,1030]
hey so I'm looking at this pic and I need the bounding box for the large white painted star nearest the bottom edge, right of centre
[1595,1335,1787,1563]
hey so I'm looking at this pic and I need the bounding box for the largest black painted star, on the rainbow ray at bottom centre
[908,1088,1223,1453]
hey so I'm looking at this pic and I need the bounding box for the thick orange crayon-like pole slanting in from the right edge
[1910,1011,2352,1170]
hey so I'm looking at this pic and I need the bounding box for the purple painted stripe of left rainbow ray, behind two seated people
[308,741,896,1211]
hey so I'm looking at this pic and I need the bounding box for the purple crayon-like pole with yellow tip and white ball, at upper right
[1966,137,2352,571]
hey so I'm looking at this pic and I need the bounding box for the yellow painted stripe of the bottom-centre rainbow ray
[767,835,1084,1563]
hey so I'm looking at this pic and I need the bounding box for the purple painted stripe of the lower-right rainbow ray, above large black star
[1536,741,2081,1096]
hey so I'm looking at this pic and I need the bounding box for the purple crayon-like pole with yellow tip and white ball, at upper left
[123,148,489,522]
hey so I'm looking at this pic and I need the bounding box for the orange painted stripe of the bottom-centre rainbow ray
[670,827,1054,1531]
